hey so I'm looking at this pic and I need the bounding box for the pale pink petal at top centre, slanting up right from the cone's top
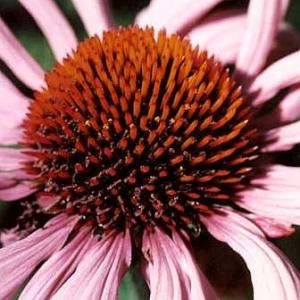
[135,0,223,33]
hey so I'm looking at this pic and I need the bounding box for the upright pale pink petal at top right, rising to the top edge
[236,0,282,77]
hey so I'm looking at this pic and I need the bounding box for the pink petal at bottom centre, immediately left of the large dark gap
[142,228,216,300]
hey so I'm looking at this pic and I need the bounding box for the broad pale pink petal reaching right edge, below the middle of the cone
[237,165,300,225]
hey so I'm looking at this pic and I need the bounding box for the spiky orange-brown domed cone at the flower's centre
[23,27,256,233]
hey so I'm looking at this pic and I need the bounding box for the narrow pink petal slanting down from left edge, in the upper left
[0,18,44,89]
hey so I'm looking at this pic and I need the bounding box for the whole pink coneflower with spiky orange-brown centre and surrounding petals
[0,0,300,300]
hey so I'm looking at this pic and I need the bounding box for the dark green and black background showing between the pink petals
[0,0,300,300]
